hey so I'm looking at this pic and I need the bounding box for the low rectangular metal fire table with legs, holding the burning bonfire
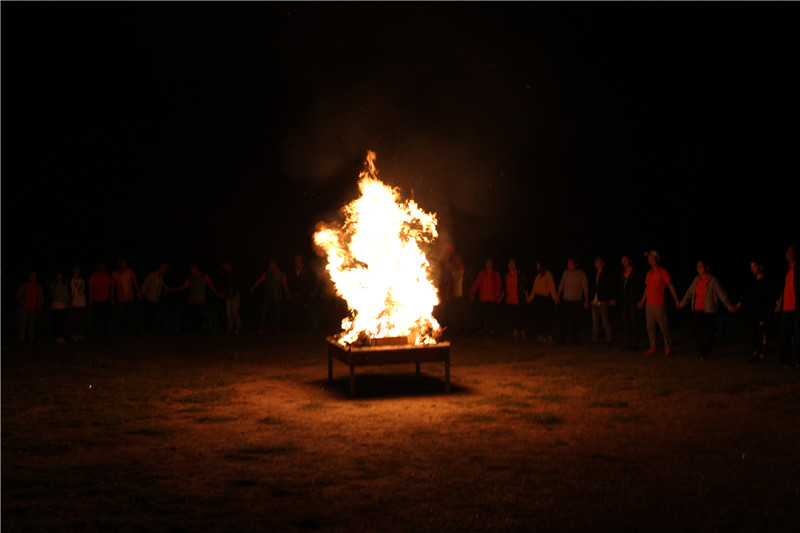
[326,337,450,397]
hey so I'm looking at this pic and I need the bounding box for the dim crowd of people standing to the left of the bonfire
[16,254,344,343]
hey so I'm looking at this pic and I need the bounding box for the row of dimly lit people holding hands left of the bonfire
[16,254,332,343]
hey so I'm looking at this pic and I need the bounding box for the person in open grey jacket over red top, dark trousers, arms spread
[678,261,739,361]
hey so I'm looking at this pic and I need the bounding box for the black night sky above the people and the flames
[2,2,800,305]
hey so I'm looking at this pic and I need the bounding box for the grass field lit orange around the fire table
[2,326,800,532]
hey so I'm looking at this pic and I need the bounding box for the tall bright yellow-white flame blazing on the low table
[314,151,440,344]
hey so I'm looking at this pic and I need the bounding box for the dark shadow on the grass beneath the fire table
[314,371,471,399]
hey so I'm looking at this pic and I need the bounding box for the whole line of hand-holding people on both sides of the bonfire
[7,246,800,368]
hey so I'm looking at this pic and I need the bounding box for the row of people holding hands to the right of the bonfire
[441,246,800,365]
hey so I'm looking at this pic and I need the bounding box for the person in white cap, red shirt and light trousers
[636,250,679,356]
